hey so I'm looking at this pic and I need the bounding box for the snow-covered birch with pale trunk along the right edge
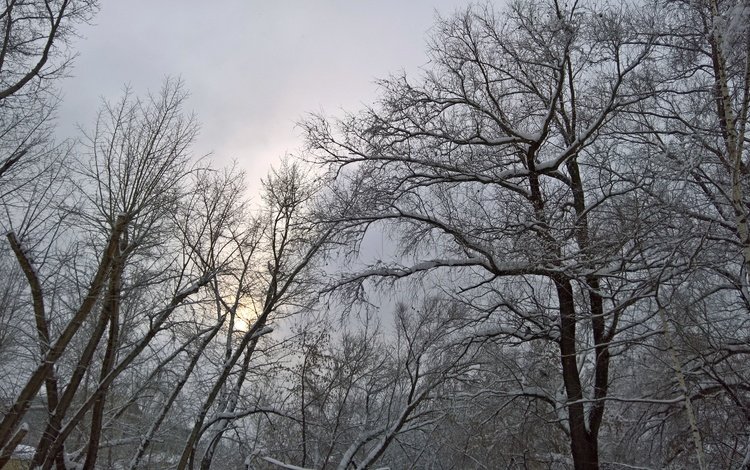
[631,1,750,467]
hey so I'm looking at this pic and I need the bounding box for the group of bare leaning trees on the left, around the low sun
[0,0,332,469]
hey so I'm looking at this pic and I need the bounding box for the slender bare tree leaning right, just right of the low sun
[178,164,336,469]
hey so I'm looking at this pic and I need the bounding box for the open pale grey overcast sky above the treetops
[59,0,469,194]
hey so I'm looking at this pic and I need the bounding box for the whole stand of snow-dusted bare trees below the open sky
[0,0,750,470]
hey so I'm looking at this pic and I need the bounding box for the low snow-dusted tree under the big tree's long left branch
[256,298,476,469]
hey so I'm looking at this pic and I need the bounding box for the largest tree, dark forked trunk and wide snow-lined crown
[306,1,672,469]
